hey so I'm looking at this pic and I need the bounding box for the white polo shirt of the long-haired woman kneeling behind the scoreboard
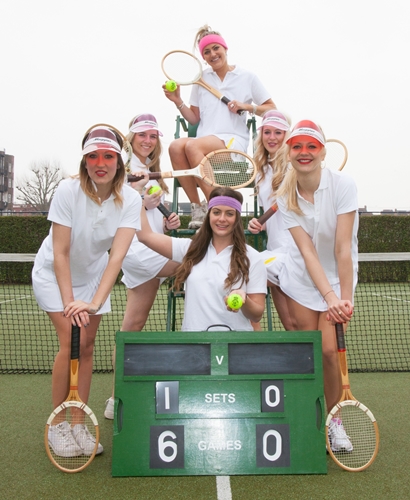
[172,238,267,332]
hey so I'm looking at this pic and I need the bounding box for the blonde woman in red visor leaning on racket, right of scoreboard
[277,120,358,451]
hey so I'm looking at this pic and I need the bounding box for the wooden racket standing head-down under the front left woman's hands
[44,326,100,472]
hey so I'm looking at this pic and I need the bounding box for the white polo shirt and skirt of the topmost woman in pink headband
[189,67,271,151]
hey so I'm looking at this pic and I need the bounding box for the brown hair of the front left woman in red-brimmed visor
[78,128,125,207]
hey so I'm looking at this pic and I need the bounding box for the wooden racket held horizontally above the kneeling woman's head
[128,149,256,189]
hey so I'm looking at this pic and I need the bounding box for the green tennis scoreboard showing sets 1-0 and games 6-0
[112,331,327,476]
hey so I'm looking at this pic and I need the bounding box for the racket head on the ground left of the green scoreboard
[44,401,100,473]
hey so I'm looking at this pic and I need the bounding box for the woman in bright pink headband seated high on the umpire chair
[164,25,275,229]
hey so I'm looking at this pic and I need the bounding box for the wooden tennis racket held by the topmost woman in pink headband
[161,50,244,115]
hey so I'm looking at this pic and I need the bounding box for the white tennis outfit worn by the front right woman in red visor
[278,168,359,311]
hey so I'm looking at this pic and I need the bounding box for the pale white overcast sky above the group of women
[0,0,410,210]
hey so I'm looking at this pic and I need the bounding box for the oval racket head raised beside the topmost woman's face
[161,50,202,85]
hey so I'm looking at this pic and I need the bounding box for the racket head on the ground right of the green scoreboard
[325,400,379,472]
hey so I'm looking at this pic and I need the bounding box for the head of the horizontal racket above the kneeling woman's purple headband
[200,149,256,189]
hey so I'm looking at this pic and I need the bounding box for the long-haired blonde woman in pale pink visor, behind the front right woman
[248,110,293,330]
